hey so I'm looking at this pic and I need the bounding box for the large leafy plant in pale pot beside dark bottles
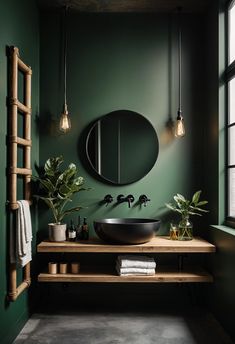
[34,156,88,241]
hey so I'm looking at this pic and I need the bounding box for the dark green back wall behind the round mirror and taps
[40,13,207,237]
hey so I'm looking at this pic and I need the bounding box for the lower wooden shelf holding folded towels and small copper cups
[38,267,213,283]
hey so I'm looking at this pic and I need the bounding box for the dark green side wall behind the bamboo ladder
[0,0,39,344]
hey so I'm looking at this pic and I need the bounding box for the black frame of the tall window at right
[225,0,235,227]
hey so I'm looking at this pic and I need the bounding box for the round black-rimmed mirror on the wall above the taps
[86,110,159,185]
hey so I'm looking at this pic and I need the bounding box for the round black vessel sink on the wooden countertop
[94,218,161,244]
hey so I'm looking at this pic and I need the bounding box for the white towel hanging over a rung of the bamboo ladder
[10,200,32,267]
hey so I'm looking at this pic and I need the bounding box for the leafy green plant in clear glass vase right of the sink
[166,190,208,240]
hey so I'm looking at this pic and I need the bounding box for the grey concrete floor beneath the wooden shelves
[14,311,233,344]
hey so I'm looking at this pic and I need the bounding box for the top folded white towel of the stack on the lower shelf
[117,255,156,269]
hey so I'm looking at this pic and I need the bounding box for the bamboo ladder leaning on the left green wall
[8,47,32,301]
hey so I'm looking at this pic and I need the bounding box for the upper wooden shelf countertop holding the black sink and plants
[37,236,215,253]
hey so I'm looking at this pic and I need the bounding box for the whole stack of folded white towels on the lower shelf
[116,255,156,276]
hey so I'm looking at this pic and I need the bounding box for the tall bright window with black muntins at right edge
[225,0,235,225]
